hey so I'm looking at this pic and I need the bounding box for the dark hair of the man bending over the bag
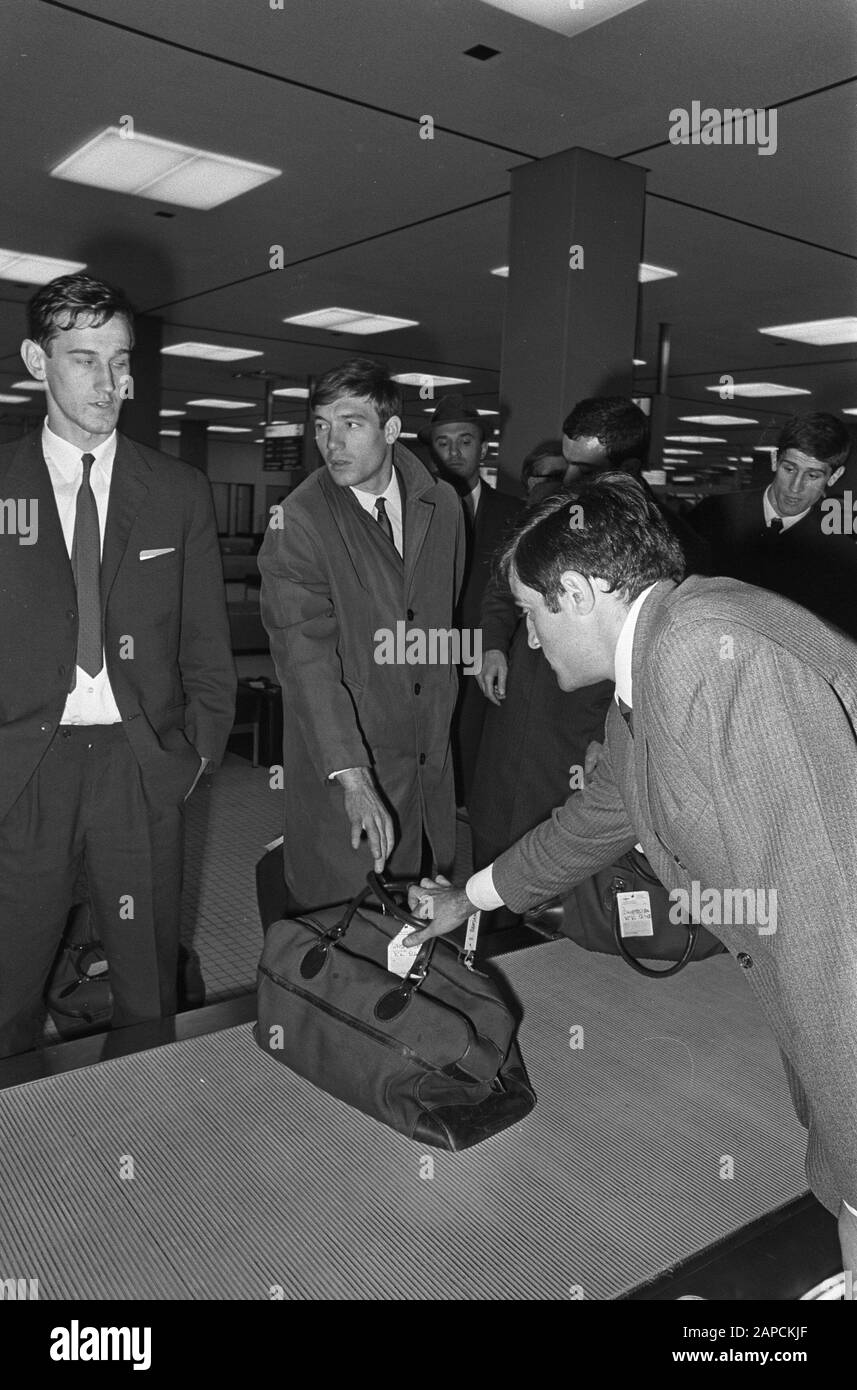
[497,473,685,613]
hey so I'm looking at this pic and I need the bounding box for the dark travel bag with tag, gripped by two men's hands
[256,874,536,1151]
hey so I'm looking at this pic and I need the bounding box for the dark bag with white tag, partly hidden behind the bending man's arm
[557,849,726,979]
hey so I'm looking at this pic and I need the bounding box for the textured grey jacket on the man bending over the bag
[493,577,857,1212]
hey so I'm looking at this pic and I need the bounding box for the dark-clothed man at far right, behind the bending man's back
[689,413,857,637]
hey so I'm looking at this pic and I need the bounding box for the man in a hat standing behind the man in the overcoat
[425,395,524,805]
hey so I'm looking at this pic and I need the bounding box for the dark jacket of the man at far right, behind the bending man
[690,489,857,638]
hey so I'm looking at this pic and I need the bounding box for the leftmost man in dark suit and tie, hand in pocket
[0,275,235,1056]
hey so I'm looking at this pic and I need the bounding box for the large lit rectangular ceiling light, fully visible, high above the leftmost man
[50,125,282,211]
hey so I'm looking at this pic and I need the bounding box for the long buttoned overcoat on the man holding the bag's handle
[258,445,464,906]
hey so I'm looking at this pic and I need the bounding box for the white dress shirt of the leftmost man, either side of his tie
[42,420,122,724]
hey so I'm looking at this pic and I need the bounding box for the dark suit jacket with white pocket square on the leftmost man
[0,431,235,817]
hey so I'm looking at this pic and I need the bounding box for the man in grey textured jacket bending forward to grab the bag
[408,474,857,1272]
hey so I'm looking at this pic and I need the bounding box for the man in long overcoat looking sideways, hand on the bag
[258,357,464,908]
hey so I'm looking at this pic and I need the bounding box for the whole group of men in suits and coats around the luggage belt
[0,275,857,1269]
